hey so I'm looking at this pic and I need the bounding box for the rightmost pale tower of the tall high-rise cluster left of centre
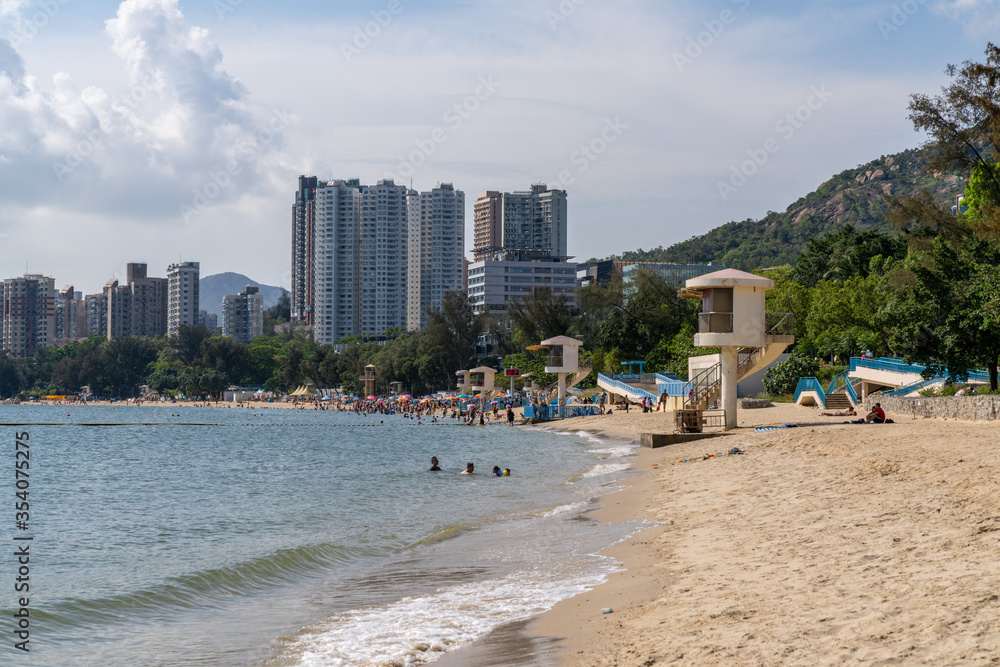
[406,183,465,331]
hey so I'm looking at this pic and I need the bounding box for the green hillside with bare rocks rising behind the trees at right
[609,149,965,271]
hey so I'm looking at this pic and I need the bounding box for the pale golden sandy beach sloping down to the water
[450,405,1000,666]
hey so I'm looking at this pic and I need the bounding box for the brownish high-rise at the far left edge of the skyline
[0,274,56,357]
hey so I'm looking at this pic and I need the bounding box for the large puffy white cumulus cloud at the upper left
[0,0,292,223]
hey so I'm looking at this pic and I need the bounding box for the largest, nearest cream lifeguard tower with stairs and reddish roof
[678,269,795,430]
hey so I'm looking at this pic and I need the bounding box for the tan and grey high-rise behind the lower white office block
[473,184,567,262]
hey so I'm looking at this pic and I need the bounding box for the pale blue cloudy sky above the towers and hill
[0,0,1000,294]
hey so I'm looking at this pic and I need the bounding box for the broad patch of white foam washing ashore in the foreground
[290,556,617,667]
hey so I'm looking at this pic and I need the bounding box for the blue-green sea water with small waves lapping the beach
[0,405,640,667]
